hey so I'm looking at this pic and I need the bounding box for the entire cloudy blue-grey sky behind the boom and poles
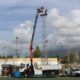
[0,0,80,55]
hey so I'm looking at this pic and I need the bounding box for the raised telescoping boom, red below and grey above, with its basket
[30,7,47,64]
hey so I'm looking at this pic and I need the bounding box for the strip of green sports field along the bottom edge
[0,77,80,80]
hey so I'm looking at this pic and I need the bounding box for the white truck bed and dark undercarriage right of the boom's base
[34,64,61,77]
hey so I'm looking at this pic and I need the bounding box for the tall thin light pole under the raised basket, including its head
[39,7,48,64]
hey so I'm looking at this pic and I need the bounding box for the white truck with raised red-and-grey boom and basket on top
[30,7,61,77]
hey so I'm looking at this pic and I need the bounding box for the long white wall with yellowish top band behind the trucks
[0,58,58,75]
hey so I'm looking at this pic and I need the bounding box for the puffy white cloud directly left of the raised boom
[14,21,32,42]
